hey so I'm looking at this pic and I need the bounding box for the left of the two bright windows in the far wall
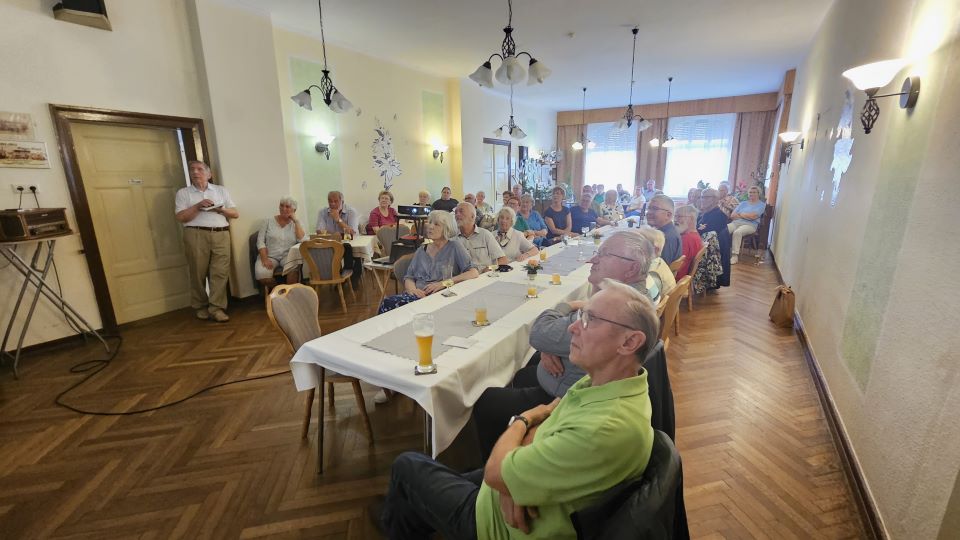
[584,122,637,193]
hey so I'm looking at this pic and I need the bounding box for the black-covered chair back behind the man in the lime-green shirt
[570,431,682,540]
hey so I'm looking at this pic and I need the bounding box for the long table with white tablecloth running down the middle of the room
[290,236,596,456]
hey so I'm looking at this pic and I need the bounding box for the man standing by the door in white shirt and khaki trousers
[175,161,240,322]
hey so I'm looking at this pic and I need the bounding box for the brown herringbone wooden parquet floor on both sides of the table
[0,264,863,539]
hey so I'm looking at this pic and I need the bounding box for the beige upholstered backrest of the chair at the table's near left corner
[267,283,320,352]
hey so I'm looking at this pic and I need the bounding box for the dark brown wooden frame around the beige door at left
[50,103,208,331]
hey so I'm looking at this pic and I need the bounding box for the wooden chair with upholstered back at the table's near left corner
[267,283,373,473]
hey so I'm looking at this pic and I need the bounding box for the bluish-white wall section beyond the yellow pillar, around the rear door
[460,78,557,202]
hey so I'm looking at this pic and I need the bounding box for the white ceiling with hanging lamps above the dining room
[224,0,833,110]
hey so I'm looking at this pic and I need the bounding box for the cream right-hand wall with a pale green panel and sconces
[774,0,960,539]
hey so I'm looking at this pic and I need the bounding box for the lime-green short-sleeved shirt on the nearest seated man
[475,371,653,539]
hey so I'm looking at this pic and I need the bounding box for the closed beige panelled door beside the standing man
[71,122,190,323]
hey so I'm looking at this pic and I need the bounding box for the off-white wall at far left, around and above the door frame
[0,0,205,345]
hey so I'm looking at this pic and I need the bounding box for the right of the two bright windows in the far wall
[663,113,737,198]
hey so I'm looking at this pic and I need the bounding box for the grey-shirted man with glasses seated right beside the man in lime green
[473,230,654,461]
